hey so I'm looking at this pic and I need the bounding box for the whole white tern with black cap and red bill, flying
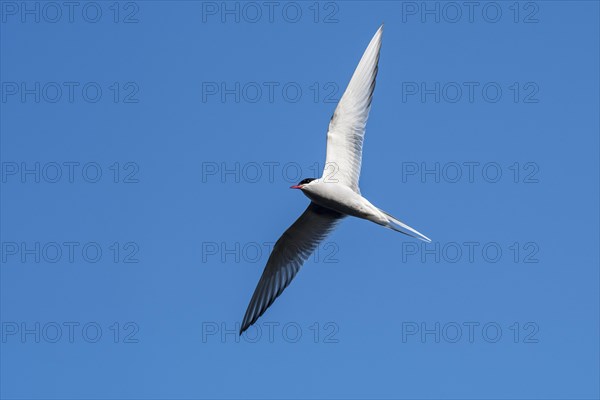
[240,25,431,335]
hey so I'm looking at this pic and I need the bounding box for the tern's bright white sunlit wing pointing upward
[323,25,383,193]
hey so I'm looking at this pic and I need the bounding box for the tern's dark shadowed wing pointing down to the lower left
[240,202,343,335]
